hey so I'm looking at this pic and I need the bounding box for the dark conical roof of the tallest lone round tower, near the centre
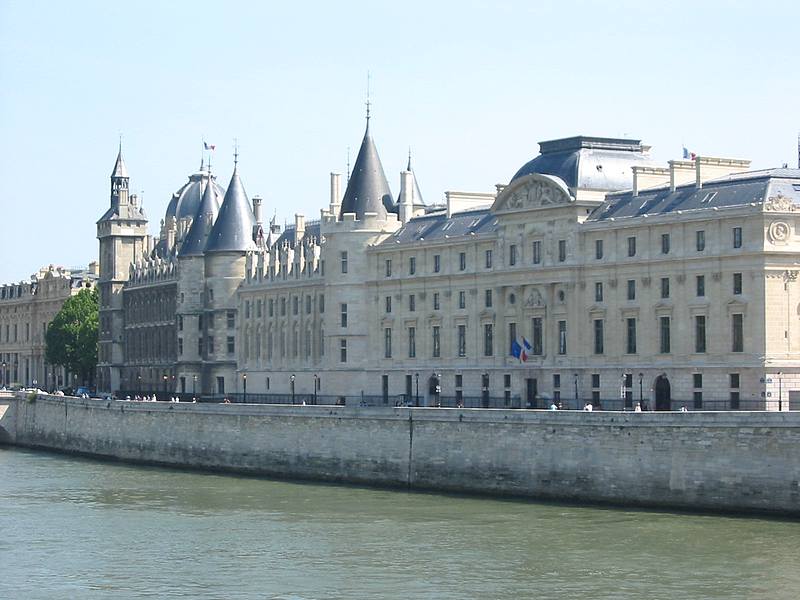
[340,120,392,220]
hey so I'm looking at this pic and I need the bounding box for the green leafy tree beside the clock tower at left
[45,288,100,385]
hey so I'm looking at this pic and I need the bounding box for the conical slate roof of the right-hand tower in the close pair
[205,167,256,253]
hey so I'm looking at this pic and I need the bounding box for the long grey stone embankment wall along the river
[0,396,800,515]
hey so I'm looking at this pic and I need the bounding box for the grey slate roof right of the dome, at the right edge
[587,169,800,221]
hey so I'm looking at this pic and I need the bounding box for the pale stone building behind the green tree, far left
[0,263,98,390]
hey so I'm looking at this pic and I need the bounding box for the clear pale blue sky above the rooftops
[0,0,800,282]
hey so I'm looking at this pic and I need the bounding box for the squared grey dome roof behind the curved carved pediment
[511,136,652,191]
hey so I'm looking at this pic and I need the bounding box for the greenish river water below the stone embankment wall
[0,448,800,600]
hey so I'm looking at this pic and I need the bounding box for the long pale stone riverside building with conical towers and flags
[97,118,800,410]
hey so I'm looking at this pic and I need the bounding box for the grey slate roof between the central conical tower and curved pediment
[379,208,497,247]
